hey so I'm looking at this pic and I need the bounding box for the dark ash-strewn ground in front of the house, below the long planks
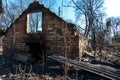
[0,57,108,80]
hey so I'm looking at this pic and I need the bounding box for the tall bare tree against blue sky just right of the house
[72,0,105,53]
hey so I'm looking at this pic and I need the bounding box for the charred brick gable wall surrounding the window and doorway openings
[3,2,87,60]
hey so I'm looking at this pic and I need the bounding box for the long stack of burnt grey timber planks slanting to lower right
[49,55,120,80]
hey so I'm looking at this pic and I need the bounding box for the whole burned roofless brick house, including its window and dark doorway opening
[3,1,88,59]
